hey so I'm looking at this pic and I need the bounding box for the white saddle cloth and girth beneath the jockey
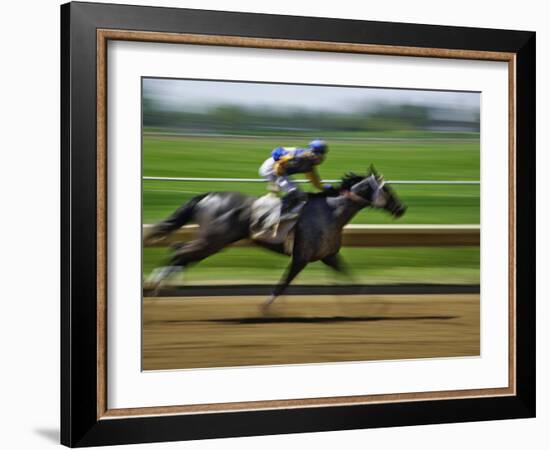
[250,193,305,254]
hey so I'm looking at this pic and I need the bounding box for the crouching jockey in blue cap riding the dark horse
[259,139,330,219]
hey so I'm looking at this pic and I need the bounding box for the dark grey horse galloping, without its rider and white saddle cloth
[144,166,406,305]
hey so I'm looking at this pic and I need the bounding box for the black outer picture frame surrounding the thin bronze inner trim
[61,2,536,447]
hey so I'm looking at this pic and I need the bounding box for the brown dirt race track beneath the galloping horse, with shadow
[143,294,480,370]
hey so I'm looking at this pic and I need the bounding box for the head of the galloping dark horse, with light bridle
[341,165,407,218]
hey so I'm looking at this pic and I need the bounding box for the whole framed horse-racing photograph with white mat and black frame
[61,3,535,447]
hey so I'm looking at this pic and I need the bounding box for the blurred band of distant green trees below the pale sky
[143,95,479,136]
